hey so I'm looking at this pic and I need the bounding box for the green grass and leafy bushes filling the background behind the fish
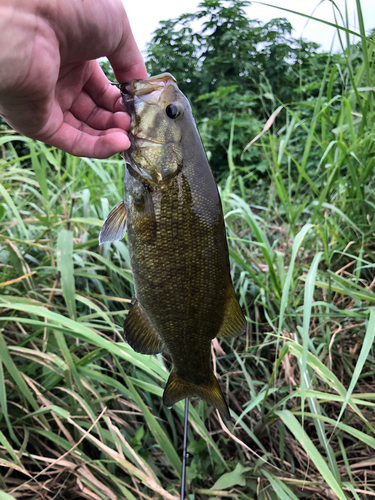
[0,0,375,500]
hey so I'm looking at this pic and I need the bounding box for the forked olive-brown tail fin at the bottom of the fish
[163,370,230,420]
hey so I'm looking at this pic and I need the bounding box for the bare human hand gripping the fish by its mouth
[0,0,147,158]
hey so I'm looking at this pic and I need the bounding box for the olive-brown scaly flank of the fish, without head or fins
[128,167,226,383]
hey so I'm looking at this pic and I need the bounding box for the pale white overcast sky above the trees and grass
[123,0,375,54]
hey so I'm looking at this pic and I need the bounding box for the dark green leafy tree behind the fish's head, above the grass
[147,0,341,178]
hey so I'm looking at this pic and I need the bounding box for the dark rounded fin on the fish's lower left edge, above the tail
[124,301,164,354]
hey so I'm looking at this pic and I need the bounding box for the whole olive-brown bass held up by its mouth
[99,73,246,419]
